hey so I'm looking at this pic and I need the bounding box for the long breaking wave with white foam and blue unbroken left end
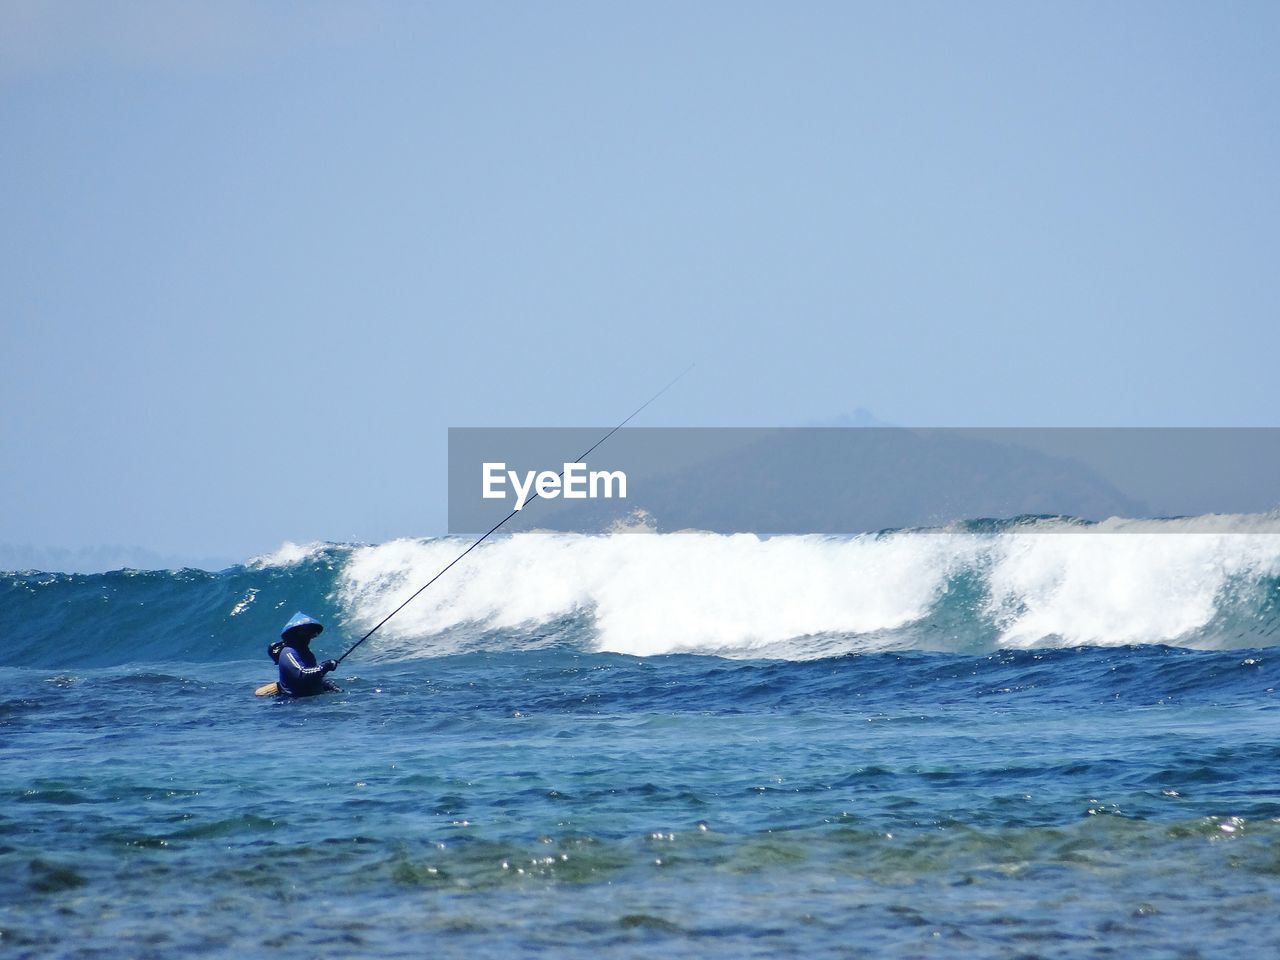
[0,517,1280,666]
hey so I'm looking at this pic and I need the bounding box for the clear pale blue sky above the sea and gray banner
[0,0,1280,559]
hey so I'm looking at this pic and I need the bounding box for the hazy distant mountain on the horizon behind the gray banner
[515,428,1149,534]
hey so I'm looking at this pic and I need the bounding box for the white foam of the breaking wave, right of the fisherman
[338,521,1280,659]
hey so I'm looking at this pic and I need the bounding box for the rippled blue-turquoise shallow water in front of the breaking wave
[0,646,1280,956]
